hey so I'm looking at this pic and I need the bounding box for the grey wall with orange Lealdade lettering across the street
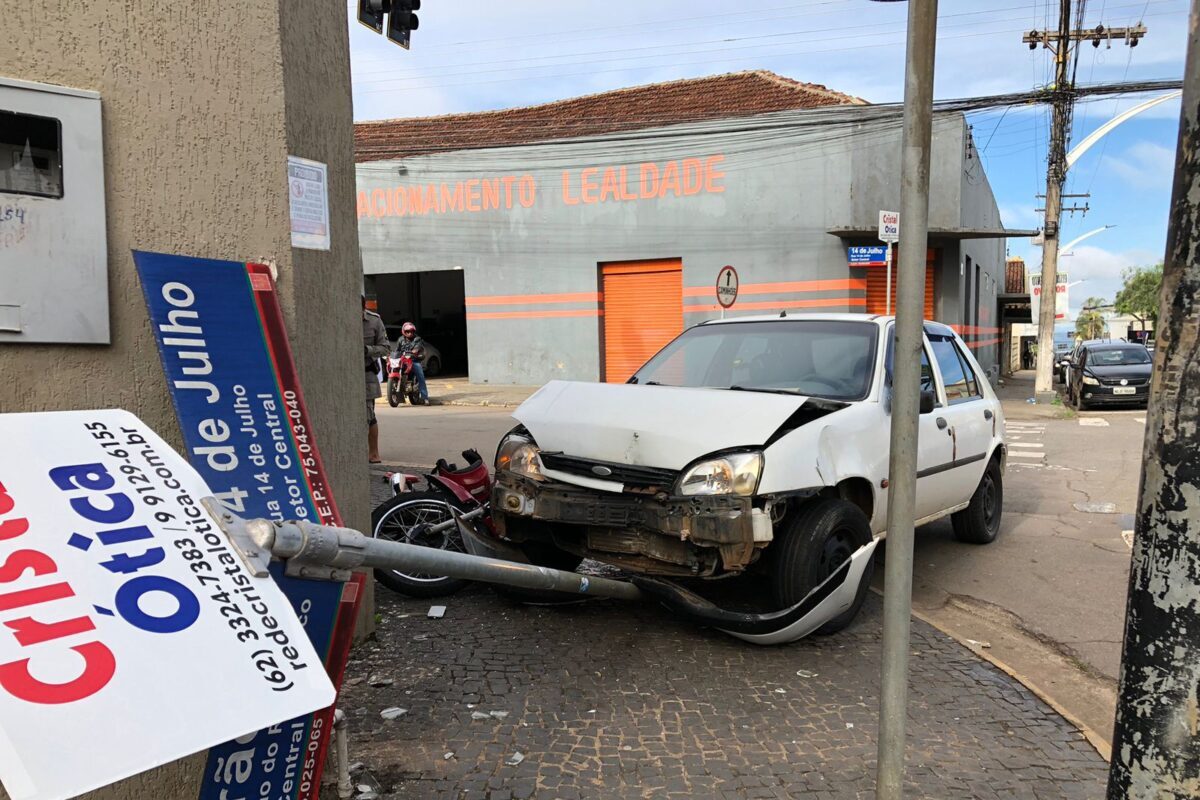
[358,107,1003,384]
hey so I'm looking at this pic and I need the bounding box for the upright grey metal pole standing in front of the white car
[875,0,937,800]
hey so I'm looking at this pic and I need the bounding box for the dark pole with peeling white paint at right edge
[1108,0,1200,800]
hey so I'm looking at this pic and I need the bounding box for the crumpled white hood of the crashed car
[512,380,808,469]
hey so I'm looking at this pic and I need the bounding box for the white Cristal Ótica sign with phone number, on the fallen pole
[0,410,334,800]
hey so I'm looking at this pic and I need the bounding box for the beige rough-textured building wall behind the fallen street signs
[0,0,368,799]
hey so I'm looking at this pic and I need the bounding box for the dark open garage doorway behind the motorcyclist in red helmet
[366,270,467,378]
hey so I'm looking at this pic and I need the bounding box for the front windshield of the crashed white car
[630,319,878,399]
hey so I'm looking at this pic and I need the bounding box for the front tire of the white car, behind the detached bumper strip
[768,498,874,634]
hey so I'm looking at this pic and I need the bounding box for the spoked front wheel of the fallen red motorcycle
[371,492,468,597]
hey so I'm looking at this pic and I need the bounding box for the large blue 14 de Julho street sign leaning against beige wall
[133,252,358,800]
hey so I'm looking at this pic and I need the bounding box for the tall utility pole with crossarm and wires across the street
[1021,0,1146,403]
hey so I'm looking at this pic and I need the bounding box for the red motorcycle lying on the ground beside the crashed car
[371,448,496,597]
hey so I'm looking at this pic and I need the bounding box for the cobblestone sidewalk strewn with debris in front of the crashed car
[326,575,1106,800]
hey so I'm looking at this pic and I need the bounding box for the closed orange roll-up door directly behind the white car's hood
[600,258,683,383]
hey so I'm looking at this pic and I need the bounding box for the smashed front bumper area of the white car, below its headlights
[492,471,772,575]
